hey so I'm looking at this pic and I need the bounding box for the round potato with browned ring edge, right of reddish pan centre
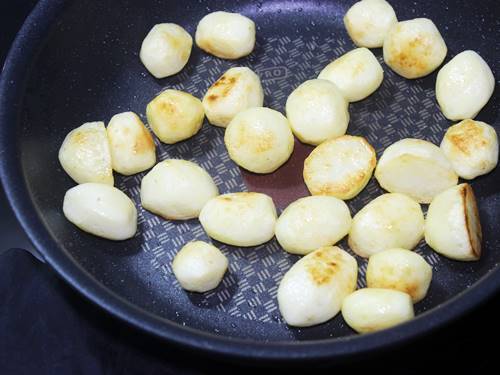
[304,135,377,199]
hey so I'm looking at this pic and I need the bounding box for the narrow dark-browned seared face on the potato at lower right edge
[460,184,483,258]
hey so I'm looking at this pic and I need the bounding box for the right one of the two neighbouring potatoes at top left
[195,11,255,59]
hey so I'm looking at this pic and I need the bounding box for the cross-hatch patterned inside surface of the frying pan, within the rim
[15,0,500,341]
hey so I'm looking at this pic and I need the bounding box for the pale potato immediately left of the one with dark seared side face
[348,193,425,258]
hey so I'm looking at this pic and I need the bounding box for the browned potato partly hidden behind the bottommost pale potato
[366,249,432,303]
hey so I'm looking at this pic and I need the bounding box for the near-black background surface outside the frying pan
[0,0,500,375]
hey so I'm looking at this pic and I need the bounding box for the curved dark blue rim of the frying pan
[0,0,500,361]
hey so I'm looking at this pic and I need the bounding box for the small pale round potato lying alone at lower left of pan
[172,241,228,293]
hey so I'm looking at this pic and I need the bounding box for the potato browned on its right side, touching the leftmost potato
[106,112,156,176]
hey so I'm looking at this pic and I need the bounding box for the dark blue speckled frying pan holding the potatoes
[0,0,500,361]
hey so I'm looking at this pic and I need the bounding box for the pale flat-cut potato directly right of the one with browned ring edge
[375,138,458,204]
